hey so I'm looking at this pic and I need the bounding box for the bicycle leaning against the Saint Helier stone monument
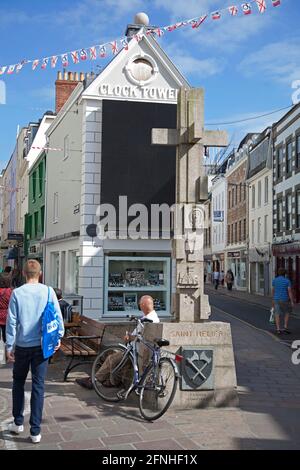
[92,316,182,421]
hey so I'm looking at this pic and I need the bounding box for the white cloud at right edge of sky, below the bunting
[238,38,300,84]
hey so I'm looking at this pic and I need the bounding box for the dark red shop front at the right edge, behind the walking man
[272,242,300,303]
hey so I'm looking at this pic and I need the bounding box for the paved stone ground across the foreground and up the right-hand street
[0,309,300,450]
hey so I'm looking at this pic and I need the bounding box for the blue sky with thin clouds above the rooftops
[0,0,300,168]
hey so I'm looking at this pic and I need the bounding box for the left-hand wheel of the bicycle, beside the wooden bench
[92,344,134,402]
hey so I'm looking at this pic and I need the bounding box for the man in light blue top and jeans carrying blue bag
[6,260,64,443]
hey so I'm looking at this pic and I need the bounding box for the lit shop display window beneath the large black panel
[104,256,171,317]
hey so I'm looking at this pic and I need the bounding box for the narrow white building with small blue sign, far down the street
[211,174,227,272]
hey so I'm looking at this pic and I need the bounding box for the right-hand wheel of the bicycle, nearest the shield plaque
[140,357,178,421]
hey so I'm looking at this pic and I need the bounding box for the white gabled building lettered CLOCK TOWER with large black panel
[44,19,189,319]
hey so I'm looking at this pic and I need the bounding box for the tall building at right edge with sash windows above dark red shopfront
[272,104,300,302]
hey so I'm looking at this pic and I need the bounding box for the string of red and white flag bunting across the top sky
[0,0,282,75]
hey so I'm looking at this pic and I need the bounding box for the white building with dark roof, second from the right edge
[247,128,273,296]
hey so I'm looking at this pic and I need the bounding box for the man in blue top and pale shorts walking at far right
[272,268,294,335]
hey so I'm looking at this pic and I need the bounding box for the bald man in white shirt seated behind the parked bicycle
[75,295,160,390]
